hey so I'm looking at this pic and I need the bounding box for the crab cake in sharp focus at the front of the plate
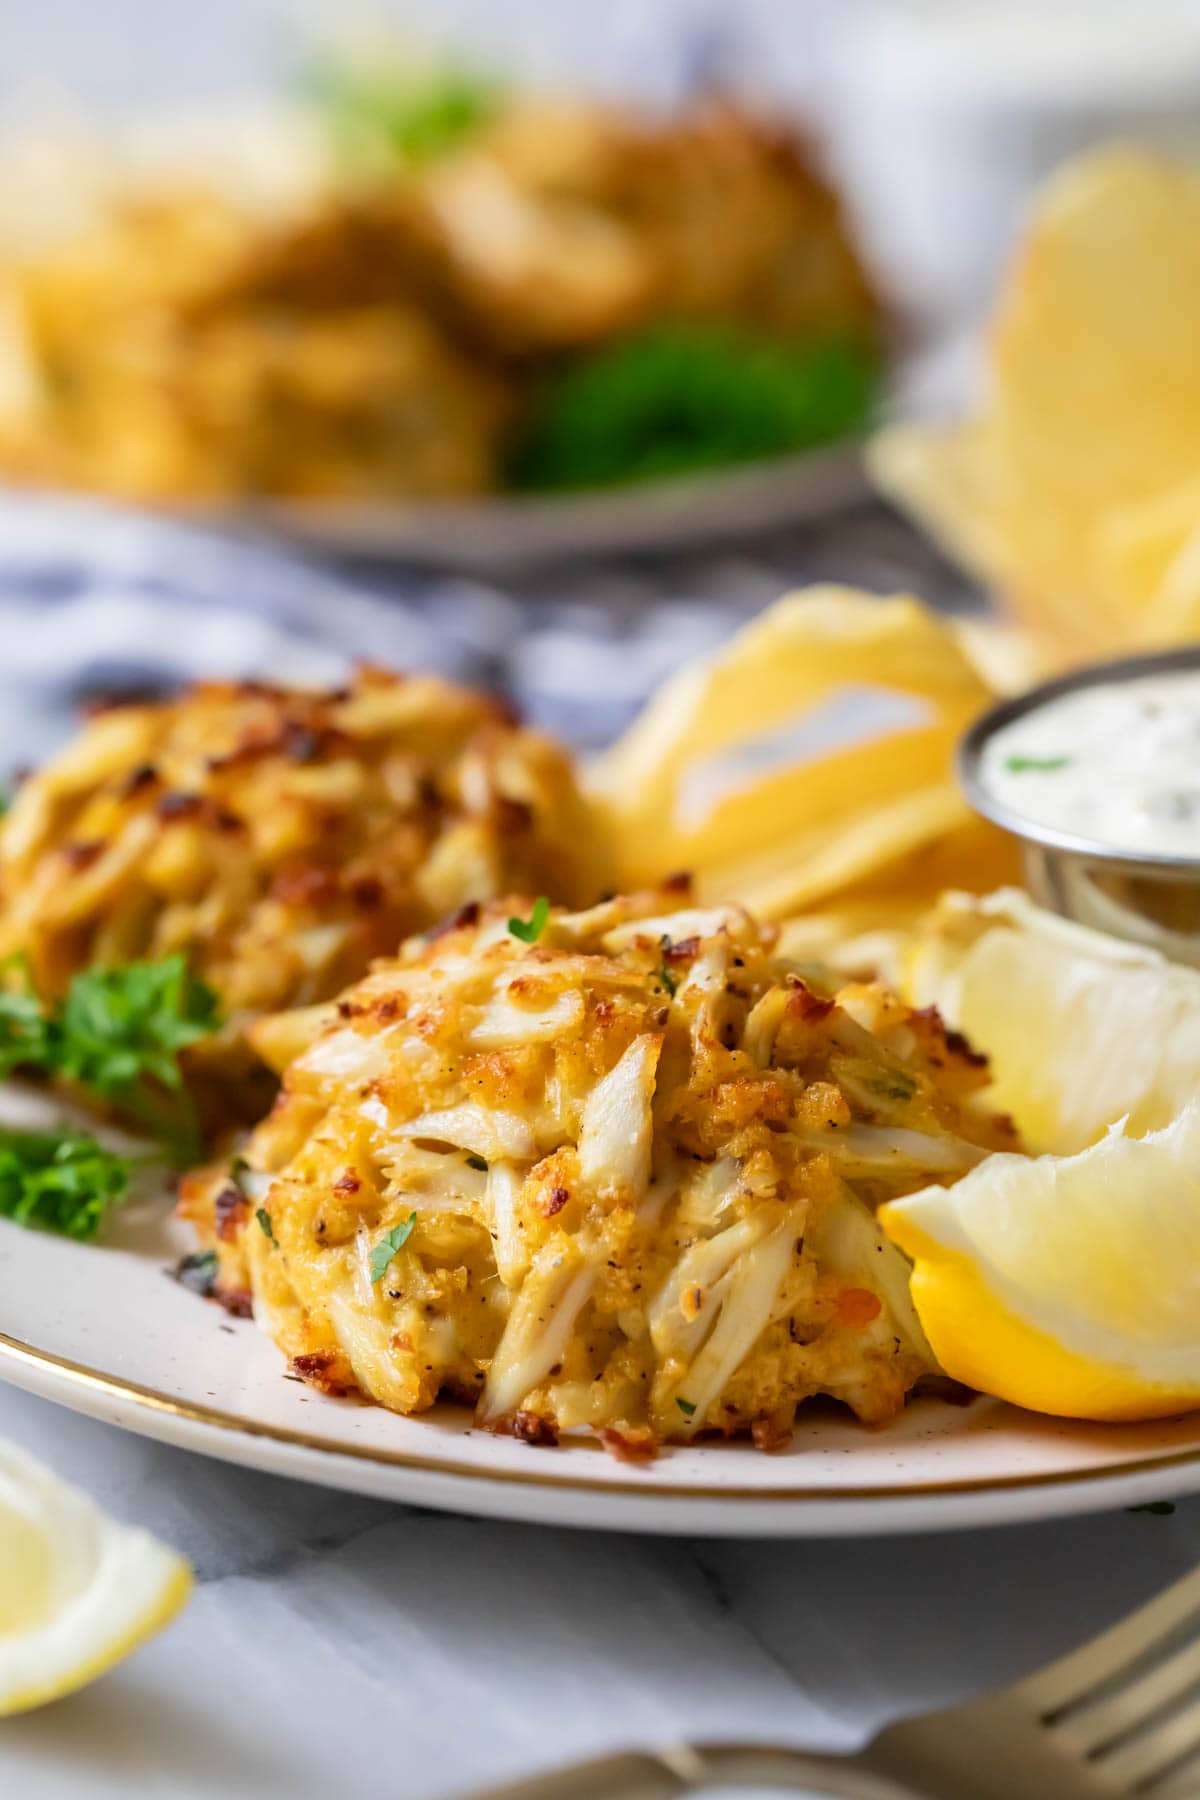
[184,891,1013,1458]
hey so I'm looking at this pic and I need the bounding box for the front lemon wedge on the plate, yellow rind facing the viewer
[880,1102,1200,1420]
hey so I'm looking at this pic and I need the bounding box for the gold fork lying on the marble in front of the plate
[475,1570,1200,1800]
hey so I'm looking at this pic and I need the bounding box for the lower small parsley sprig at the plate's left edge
[0,1127,130,1242]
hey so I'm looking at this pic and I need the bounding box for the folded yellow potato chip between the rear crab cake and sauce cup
[592,587,1013,918]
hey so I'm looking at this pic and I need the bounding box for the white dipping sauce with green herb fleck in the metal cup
[979,668,1200,857]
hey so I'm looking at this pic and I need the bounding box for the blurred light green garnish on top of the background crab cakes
[302,61,504,164]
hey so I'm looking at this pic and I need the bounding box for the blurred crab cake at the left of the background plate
[0,191,511,500]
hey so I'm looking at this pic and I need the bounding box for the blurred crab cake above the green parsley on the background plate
[396,97,880,356]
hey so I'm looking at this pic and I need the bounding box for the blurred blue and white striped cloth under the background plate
[0,495,963,769]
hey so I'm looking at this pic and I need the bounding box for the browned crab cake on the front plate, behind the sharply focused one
[0,668,596,1116]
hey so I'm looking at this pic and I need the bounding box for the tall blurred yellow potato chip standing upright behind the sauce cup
[871,148,1200,659]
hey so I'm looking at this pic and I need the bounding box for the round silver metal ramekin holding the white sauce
[957,644,1200,967]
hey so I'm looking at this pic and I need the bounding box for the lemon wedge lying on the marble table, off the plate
[0,1445,191,1715]
